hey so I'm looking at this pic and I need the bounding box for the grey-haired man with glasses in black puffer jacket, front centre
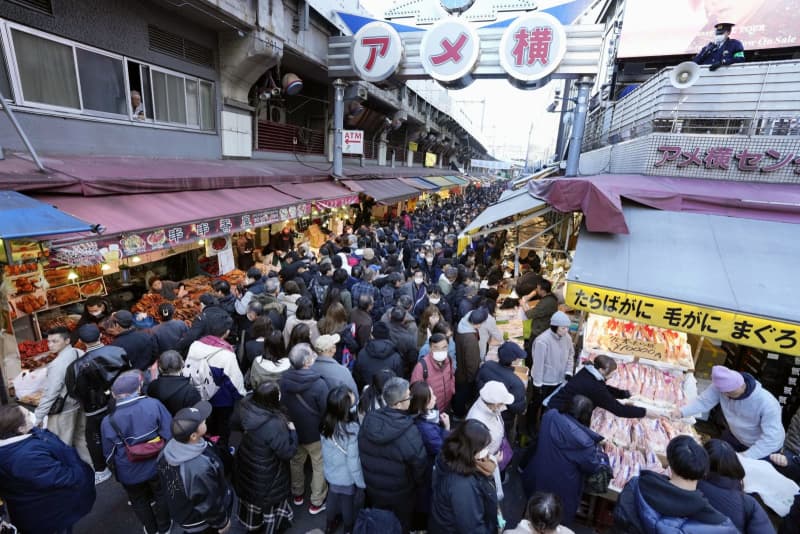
[358,378,428,532]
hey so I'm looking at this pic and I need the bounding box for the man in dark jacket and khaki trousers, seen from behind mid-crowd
[280,343,328,515]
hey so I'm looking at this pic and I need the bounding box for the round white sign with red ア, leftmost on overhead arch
[350,21,403,82]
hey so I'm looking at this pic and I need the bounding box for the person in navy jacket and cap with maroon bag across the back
[100,369,172,534]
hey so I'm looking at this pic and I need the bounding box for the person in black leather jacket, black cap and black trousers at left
[66,323,131,484]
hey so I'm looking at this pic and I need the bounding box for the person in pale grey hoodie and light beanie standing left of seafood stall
[527,311,575,432]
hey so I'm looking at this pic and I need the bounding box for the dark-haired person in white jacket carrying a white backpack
[183,308,247,446]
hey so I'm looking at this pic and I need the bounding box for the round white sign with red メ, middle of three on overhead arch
[420,18,481,82]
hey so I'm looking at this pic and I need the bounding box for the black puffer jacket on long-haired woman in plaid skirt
[233,395,297,509]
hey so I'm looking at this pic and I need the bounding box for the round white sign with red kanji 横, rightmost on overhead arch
[499,13,567,82]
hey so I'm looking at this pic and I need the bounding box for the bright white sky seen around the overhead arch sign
[360,0,563,161]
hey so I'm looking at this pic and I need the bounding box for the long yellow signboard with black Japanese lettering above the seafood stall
[566,282,800,356]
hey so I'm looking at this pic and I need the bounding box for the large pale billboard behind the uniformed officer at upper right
[617,0,800,58]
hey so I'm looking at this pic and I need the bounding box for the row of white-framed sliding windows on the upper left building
[0,21,216,131]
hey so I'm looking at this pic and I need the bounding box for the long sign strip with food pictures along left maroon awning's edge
[53,204,311,265]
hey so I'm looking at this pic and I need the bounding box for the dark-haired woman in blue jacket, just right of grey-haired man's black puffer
[408,380,450,530]
